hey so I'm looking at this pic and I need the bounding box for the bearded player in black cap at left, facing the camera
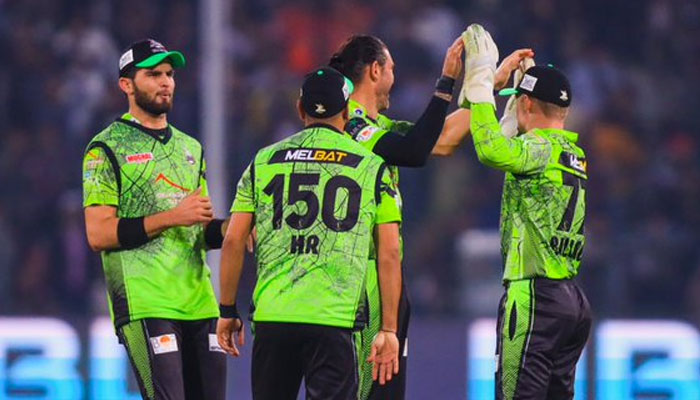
[83,39,226,400]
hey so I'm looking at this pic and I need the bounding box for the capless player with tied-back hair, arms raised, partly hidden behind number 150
[330,35,534,400]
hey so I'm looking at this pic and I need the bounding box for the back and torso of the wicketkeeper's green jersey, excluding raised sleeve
[501,129,588,281]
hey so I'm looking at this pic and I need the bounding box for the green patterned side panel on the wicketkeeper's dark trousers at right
[498,280,535,400]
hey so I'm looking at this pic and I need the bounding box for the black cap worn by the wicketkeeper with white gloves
[498,65,572,107]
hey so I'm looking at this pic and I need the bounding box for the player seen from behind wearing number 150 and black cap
[217,67,401,400]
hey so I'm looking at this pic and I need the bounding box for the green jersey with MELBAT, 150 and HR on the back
[231,125,401,328]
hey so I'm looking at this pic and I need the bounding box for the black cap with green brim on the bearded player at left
[119,39,185,77]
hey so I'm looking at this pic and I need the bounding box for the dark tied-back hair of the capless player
[328,35,387,84]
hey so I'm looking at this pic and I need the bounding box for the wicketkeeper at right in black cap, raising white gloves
[462,24,591,400]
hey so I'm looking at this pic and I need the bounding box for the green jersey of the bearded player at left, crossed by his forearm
[83,114,219,327]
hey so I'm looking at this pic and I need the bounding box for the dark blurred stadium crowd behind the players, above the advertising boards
[0,0,700,323]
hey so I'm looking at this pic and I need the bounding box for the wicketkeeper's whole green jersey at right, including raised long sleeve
[471,104,588,281]
